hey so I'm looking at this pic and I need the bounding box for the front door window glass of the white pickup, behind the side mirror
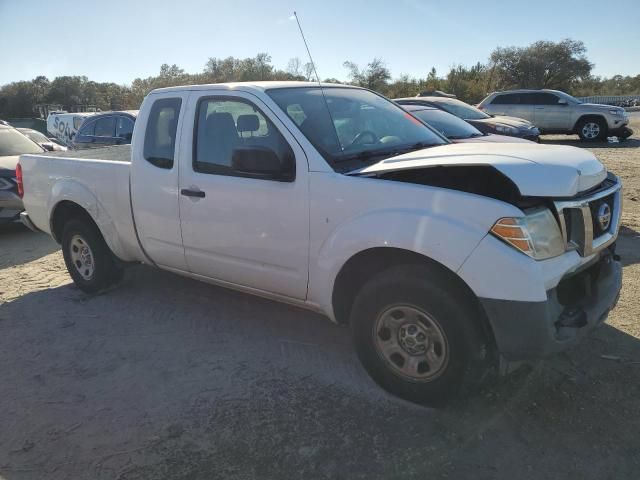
[193,97,293,176]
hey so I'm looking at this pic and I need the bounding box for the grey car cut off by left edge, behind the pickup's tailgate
[0,124,45,225]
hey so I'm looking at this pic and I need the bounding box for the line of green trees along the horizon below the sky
[0,39,640,118]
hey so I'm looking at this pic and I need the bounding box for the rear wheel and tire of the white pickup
[62,219,123,293]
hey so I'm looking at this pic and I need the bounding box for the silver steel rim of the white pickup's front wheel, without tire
[373,305,449,382]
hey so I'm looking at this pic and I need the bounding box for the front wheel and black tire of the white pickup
[350,265,489,407]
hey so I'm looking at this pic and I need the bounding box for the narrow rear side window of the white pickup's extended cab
[144,98,182,168]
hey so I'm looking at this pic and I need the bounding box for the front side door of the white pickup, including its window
[180,90,309,300]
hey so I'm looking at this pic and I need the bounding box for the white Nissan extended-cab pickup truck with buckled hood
[17,82,622,405]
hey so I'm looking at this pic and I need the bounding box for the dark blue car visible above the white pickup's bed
[73,110,138,149]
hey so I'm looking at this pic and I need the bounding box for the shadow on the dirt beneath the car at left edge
[0,223,60,269]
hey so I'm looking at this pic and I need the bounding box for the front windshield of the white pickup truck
[267,87,447,164]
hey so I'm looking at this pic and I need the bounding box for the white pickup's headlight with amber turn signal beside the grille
[491,208,566,260]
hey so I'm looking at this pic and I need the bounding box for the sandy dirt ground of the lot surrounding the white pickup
[0,120,640,480]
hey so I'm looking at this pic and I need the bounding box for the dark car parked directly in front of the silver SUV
[395,97,540,142]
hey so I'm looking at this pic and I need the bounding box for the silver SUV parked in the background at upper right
[478,90,633,141]
